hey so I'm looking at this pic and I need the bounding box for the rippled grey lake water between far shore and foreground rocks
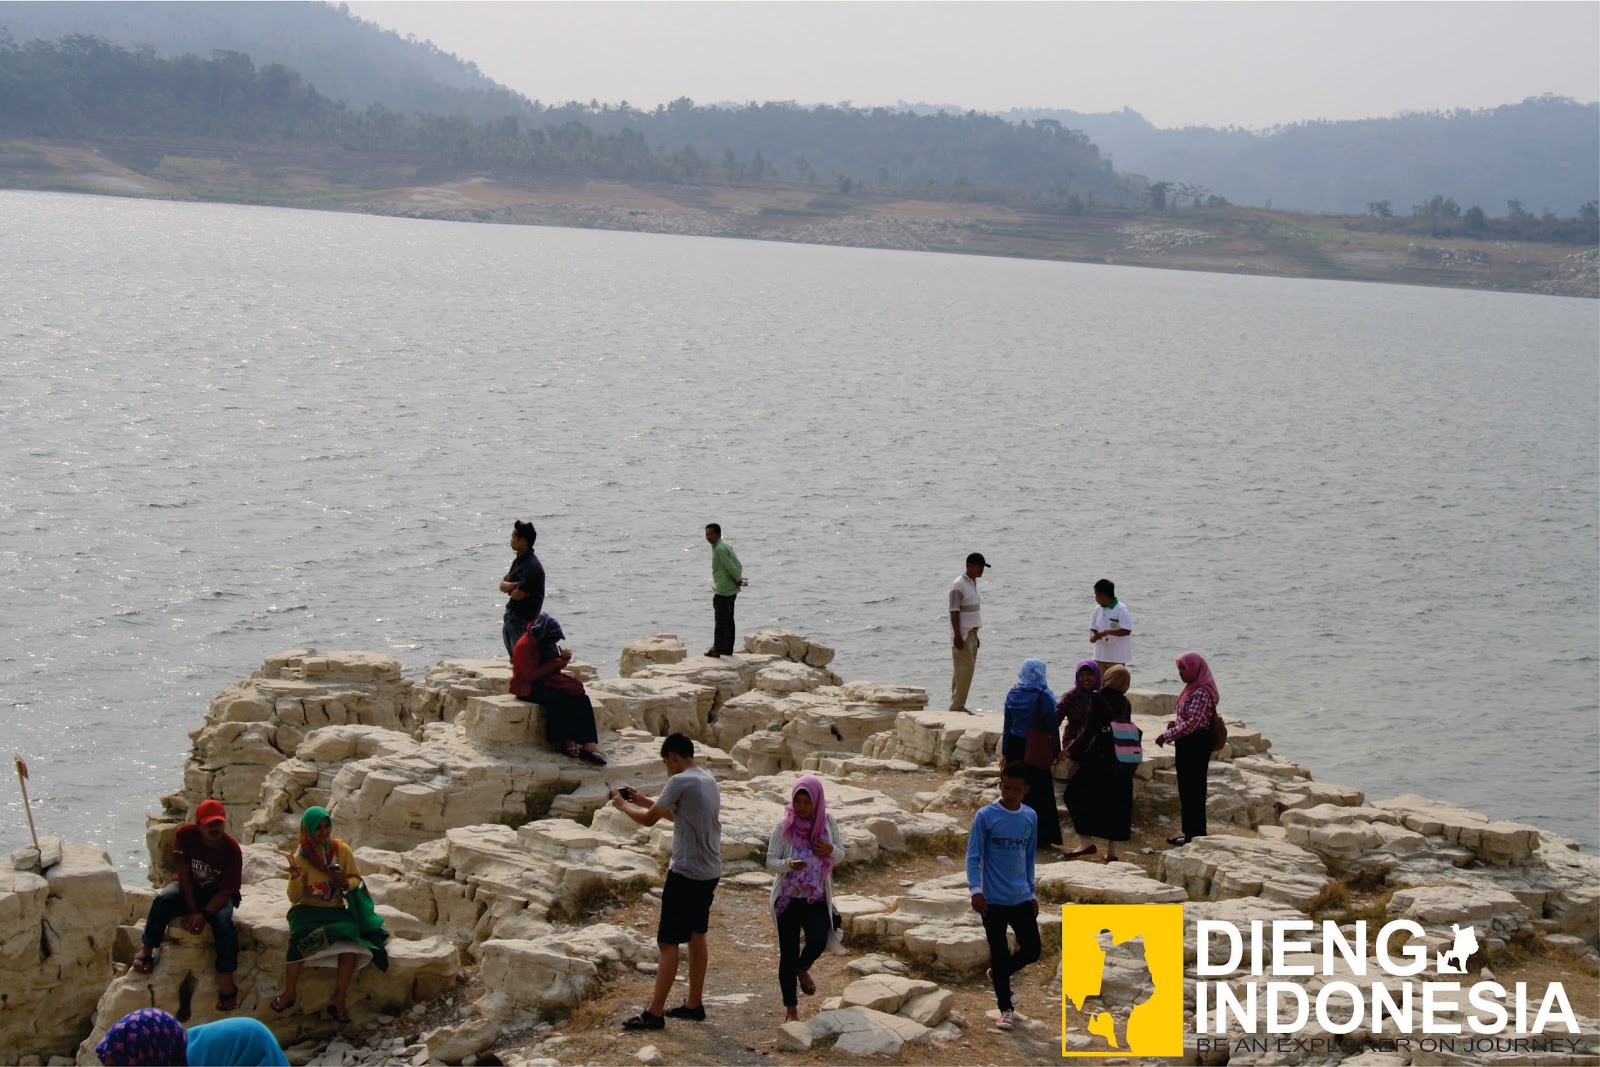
[0,192,1600,872]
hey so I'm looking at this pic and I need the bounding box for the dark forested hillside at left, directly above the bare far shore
[0,35,1144,202]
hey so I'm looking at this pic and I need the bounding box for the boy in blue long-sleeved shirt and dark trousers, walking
[966,763,1040,1030]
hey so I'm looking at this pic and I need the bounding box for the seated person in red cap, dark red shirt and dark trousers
[133,800,245,1011]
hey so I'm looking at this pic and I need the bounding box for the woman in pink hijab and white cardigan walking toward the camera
[766,774,843,1022]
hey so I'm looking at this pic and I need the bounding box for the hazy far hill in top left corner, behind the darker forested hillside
[0,0,528,122]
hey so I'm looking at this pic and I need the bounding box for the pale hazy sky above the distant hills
[350,0,1600,126]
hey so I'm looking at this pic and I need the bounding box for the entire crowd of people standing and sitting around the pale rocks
[96,531,1221,1064]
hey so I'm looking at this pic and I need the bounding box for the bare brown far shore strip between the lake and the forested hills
[0,139,1600,299]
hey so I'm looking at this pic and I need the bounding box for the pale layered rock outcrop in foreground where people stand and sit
[9,632,1600,1064]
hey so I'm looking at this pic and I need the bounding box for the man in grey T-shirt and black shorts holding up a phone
[611,734,722,1030]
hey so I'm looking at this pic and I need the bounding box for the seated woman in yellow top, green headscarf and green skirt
[272,808,389,1022]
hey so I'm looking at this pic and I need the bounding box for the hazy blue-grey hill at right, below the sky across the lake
[1005,96,1600,218]
